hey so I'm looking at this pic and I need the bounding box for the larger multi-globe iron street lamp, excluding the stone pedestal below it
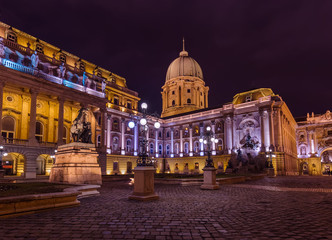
[128,103,160,166]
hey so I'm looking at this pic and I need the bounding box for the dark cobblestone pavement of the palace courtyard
[0,177,332,239]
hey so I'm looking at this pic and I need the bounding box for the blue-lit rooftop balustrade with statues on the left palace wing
[0,38,106,98]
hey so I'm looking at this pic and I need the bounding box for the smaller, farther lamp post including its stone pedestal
[199,126,219,190]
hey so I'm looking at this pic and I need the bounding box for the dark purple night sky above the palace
[0,0,332,117]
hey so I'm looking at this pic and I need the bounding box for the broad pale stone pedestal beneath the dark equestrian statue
[50,142,102,185]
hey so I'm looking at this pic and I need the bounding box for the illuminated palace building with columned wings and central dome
[0,22,332,178]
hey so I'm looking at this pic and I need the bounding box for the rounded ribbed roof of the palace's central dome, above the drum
[166,48,203,81]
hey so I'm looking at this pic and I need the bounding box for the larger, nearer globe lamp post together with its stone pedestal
[128,103,160,201]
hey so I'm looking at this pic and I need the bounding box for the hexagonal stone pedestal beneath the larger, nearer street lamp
[128,166,159,201]
